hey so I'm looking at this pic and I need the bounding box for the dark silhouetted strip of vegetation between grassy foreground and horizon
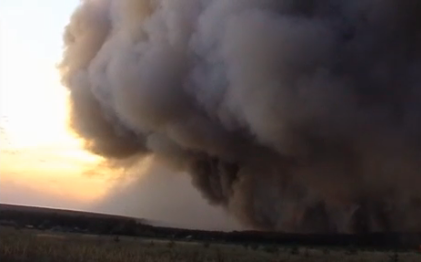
[0,204,421,250]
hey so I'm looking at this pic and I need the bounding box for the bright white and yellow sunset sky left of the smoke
[0,0,111,209]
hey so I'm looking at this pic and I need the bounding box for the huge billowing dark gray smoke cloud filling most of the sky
[60,0,421,232]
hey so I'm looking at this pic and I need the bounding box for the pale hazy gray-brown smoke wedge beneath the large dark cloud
[92,161,243,231]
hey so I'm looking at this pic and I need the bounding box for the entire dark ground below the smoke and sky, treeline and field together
[0,204,421,262]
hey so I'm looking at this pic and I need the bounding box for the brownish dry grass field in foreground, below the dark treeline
[0,227,421,262]
